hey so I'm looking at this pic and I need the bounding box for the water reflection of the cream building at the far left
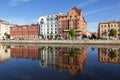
[0,45,11,63]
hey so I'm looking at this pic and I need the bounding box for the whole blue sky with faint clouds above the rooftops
[0,0,120,31]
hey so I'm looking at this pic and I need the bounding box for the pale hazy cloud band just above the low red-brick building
[2,17,38,25]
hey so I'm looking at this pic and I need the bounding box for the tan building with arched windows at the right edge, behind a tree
[98,20,120,39]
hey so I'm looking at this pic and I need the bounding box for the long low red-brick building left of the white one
[10,24,39,39]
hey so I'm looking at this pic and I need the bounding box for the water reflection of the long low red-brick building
[10,46,38,59]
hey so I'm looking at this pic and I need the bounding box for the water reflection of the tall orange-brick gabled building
[58,47,87,76]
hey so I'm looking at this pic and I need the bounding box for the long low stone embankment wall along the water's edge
[0,40,120,45]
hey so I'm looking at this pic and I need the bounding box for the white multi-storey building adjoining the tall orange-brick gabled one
[38,14,58,39]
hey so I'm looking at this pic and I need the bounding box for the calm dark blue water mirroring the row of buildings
[0,44,120,80]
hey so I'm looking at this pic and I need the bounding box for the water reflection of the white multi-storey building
[39,47,58,69]
